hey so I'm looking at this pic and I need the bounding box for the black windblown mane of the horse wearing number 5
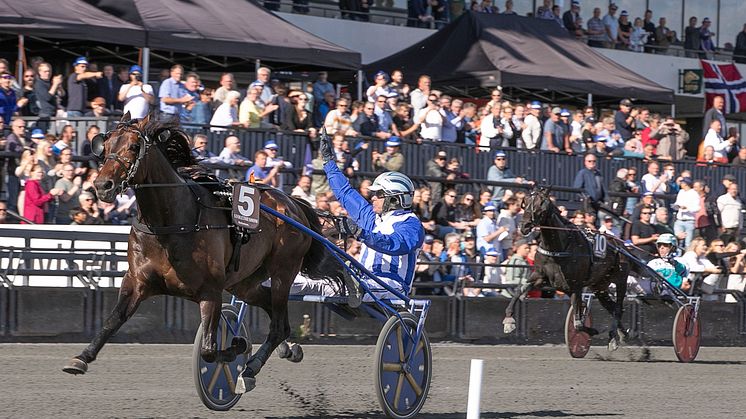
[138,114,197,169]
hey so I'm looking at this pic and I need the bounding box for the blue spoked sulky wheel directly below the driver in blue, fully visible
[374,313,432,418]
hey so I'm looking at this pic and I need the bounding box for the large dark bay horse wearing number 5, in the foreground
[64,114,343,388]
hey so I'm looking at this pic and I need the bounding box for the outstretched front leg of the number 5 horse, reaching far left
[62,271,151,374]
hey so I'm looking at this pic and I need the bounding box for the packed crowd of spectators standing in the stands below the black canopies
[0,52,746,295]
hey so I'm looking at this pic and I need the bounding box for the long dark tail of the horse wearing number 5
[292,197,346,290]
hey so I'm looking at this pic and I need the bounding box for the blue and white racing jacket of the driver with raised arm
[324,161,425,294]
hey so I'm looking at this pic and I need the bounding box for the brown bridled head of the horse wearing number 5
[91,112,148,202]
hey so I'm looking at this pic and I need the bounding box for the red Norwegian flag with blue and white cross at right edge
[700,60,746,114]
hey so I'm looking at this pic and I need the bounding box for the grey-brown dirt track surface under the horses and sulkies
[0,344,746,419]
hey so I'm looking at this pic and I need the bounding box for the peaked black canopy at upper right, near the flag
[365,12,673,103]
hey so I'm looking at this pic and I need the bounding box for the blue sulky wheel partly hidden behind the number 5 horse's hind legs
[192,304,251,410]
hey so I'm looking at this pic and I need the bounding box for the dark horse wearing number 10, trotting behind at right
[503,187,630,350]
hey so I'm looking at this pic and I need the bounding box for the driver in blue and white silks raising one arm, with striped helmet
[320,133,425,301]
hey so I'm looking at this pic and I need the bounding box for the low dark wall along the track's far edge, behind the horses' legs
[0,287,746,346]
